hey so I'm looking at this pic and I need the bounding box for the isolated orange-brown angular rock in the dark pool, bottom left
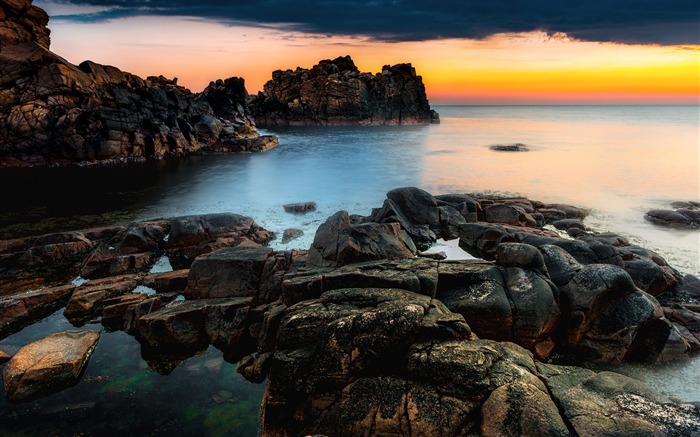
[3,331,100,402]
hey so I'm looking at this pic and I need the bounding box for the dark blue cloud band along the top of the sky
[45,0,700,44]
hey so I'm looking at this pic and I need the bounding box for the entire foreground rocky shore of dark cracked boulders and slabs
[0,187,700,436]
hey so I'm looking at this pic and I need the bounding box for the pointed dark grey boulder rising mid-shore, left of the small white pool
[308,211,415,267]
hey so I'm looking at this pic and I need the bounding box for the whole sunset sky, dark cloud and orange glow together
[34,0,700,105]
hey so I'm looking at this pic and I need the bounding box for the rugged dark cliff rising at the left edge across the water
[0,0,277,167]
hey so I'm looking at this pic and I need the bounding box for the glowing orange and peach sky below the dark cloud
[49,17,700,105]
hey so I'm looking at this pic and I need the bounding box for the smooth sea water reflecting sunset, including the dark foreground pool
[0,106,700,436]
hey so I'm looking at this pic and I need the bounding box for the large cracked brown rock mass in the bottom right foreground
[262,289,700,436]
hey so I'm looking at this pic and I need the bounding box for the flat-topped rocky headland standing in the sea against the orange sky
[249,56,439,126]
